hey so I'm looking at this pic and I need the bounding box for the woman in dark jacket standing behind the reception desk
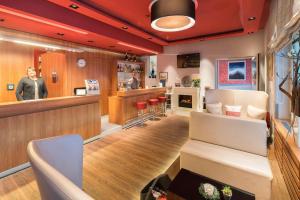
[16,67,48,101]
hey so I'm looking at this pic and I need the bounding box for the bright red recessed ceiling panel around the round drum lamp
[80,0,243,41]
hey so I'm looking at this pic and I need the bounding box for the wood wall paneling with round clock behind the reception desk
[0,36,121,115]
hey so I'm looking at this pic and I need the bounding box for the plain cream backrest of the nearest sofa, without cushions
[189,112,267,156]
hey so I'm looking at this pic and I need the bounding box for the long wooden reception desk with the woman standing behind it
[0,95,101,176]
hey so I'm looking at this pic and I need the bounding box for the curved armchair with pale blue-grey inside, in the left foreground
[27,135,93,200]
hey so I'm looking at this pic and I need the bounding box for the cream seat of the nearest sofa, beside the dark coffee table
[180,140,273,200]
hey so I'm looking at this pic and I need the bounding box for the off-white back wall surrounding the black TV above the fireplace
[157,31,264,88]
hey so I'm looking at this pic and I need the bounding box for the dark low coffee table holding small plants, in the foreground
[167,169,255,200]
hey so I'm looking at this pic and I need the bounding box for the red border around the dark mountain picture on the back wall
[218,59,252,85]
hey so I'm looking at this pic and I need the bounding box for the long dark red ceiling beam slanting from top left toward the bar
[0,0,163,53]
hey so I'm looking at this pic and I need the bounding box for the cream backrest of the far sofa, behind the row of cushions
[205,89,268,117]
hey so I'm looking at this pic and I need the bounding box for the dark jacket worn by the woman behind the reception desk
[16,77,48,101]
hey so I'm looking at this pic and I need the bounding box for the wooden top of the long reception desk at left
[0,95,100,118]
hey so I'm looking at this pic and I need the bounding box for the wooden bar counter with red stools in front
[109,88,166,125]
